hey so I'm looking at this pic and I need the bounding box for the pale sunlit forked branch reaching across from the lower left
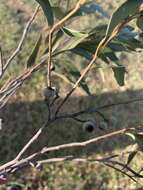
[0,128,134,175]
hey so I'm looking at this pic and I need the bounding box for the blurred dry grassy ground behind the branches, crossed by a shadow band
[0,0,143,190]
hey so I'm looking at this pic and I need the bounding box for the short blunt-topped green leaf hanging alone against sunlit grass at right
[112,66,126,86]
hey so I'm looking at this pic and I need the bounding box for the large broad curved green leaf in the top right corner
[106,0,143,36]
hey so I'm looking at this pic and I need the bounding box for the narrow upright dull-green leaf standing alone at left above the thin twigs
[27,35,42,67]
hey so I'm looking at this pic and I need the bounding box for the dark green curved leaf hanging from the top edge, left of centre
[36,0,54,26]
